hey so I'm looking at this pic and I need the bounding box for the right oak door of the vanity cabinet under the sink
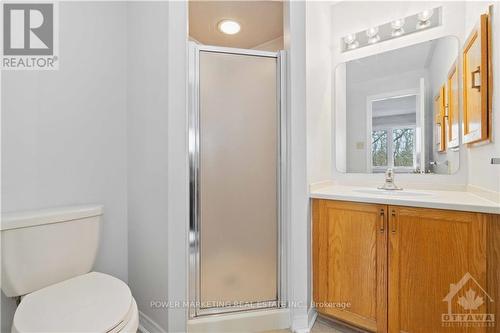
[388,206,491,333]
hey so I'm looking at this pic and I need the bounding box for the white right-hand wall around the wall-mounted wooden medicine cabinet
[465,1,500,193]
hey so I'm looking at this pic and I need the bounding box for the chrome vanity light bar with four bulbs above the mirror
[341,7,443,52]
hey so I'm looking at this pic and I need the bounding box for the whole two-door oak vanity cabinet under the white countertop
[313,199,500,333]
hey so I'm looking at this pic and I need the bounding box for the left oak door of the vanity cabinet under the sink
[313,199,387,332]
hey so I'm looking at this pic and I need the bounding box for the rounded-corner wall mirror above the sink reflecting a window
[335,36,459,174]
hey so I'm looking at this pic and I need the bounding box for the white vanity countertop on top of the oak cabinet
[309,185,500,214]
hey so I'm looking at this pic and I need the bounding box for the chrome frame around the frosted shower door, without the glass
[188,42,288,318]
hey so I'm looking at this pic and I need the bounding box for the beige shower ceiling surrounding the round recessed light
[189,1,283,48]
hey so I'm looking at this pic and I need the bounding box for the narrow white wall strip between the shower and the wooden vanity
[285,1,311,332]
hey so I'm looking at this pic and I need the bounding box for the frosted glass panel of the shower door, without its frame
[198,51,279,309]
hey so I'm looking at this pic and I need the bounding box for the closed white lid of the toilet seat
[13,272,132,332]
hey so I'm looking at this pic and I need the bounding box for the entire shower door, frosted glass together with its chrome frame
[189,43,286,318]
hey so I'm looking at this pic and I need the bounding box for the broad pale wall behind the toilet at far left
[1,2,128,332]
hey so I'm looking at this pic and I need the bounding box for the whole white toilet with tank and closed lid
[0,206,139,333]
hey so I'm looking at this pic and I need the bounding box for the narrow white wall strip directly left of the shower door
[167,1,188,332]
